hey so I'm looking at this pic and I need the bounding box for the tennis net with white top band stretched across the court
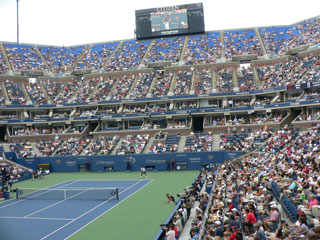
[16,188,119,201]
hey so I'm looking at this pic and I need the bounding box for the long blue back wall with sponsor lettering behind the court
[13,151,242,172]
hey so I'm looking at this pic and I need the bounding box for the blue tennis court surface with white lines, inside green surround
[0,180,152,240]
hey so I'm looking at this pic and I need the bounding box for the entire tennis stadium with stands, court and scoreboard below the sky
[0,0,320,240]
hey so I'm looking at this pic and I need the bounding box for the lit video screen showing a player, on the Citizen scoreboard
[151,9,188,32]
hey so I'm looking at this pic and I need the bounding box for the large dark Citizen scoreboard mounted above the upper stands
[136,3,205,39]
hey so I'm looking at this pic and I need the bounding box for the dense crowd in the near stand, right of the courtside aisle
[199,126,320,240]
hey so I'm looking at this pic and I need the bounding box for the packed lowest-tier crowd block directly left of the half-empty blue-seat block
[116,134,149,155]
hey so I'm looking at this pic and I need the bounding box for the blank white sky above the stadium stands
[0,0,320,46]
